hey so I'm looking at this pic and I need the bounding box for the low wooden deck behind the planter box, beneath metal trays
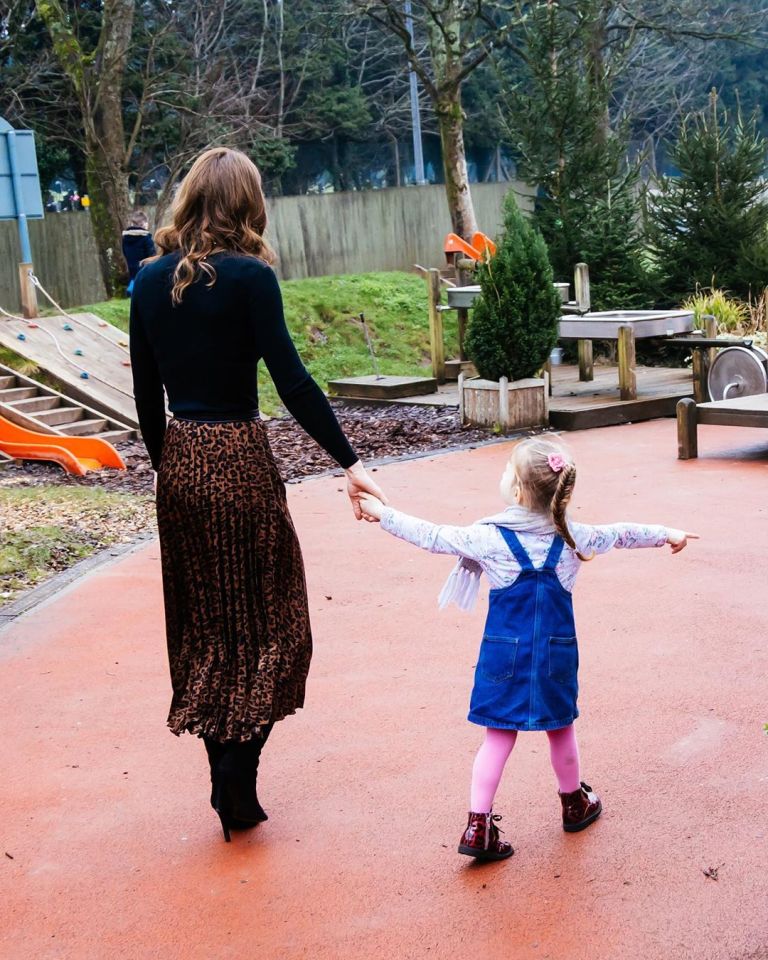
[332,365,693,430]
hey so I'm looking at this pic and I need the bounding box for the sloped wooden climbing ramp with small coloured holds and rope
[0,313,138,427]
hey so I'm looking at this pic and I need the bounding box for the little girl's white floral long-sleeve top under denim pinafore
[381,507,669,593]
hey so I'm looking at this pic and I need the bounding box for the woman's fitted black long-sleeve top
[130,253,357,470]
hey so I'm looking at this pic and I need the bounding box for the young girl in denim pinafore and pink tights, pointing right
[361,438,694,860]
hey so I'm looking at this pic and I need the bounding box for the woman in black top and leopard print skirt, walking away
[130,147,390,841]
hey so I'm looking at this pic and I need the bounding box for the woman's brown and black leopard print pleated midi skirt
[157,419,312,741]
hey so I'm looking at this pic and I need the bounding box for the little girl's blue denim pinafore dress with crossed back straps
[469,527,579,730]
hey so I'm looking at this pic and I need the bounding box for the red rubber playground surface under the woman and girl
[0,421,768,960]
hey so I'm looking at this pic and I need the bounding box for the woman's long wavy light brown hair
[146,147,275,305]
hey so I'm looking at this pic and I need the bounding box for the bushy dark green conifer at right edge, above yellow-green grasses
[646,91,768,301]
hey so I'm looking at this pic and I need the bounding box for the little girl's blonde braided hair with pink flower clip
[511,437,592,560]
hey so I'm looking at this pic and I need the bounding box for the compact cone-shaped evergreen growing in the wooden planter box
[465,192,561,380]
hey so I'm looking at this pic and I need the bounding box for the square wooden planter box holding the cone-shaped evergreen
[459,374,549,433]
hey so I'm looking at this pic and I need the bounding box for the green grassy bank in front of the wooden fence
[78,273,457,414]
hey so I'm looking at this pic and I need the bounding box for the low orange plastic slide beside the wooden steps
[0,417,125,477]
